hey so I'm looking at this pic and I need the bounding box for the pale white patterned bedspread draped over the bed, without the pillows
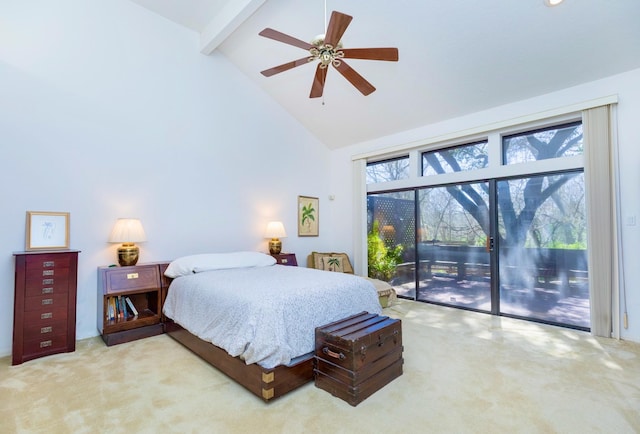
[163,265,382,368]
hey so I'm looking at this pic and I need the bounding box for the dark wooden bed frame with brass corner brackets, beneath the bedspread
[160,263,313,402]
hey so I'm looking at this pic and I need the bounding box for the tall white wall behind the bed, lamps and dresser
[0,0,330,356]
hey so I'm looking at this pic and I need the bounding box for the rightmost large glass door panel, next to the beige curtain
[497,172,590,328]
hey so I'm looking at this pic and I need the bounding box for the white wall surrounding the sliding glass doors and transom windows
[331,69,640,342]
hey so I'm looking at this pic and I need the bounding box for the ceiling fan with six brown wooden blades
[259,11,398,98]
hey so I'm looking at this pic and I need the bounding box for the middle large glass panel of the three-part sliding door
[417,182,491,312]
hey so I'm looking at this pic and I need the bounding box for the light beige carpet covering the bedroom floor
[0,301,640,434]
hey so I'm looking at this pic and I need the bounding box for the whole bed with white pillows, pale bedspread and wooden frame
[163,252,381,401]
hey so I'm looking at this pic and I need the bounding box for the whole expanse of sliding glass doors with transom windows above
[367,118,590,330]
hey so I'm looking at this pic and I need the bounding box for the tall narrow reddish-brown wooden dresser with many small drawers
[12,250,79,365]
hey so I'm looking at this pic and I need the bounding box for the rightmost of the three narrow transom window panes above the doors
[502,122,583,164]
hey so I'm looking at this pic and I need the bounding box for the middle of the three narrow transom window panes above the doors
[422,142,489,176]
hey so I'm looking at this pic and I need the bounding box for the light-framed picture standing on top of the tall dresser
[26,211,69,250]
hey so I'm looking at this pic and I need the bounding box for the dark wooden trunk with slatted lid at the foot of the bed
[314,312,404,406]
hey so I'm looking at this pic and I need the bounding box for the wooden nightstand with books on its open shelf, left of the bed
[98,263,166,346]
